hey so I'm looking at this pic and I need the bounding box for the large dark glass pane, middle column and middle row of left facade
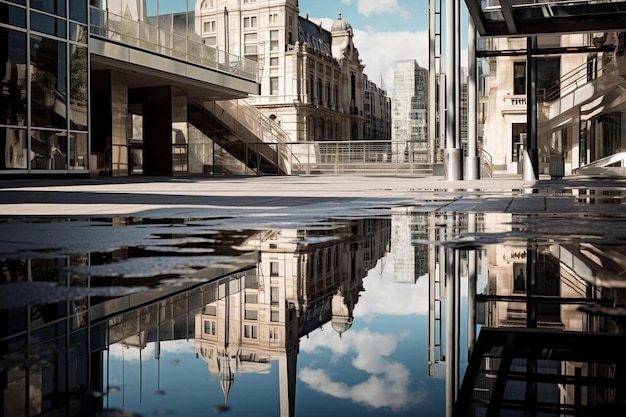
[30,36,67,129]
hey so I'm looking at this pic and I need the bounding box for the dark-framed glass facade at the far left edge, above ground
[0,0,89,173]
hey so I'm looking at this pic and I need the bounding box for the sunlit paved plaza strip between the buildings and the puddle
[0,174,626,218]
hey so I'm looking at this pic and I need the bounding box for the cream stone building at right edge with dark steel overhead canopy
[467,0,626,177]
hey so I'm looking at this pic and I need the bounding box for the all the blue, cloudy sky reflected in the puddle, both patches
[105,255,458,417]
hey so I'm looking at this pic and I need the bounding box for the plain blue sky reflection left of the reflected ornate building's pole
[104,339,279,417]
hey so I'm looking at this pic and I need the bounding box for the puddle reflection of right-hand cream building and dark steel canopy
[453,213,626,415]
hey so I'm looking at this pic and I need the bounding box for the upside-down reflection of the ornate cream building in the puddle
[195,219,390,416]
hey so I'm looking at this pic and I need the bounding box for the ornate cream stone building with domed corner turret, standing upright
[195,0,366,142]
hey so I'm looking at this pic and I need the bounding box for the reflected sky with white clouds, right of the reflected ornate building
[296,252,444,416]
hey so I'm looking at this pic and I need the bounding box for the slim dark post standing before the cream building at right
[522,36,539,181]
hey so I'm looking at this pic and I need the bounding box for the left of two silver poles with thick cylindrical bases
[443,0,463,181]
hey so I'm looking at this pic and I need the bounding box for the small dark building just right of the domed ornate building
[363,74,391,140]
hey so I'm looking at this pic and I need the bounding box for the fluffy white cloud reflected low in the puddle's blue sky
[298,330,426,410]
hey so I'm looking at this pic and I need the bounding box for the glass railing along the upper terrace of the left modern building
[90,6,258,82]
